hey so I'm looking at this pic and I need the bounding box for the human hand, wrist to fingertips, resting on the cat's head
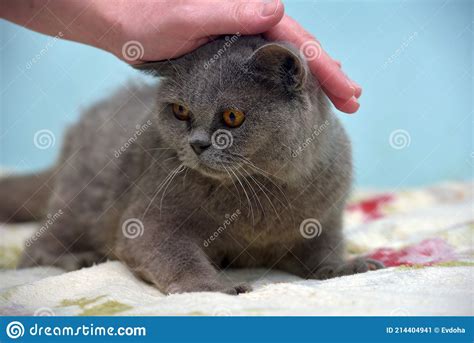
[100,0,362,113]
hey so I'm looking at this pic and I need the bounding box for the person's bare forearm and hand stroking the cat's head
[0,0,362,113]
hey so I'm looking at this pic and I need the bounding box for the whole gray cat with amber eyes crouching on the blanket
[0,36,383,294]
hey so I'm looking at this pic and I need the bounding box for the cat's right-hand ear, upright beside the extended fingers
[247,43,308,90]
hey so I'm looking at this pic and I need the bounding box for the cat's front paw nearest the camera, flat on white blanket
[166,280,252,295]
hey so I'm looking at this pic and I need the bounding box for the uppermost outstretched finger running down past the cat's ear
[266,16,356,99]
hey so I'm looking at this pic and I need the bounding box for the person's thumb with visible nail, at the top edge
[188,0,284,36]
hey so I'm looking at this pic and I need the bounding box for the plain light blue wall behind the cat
[0,0,474,188]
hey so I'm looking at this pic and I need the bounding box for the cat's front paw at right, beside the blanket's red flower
[311,257,385,280]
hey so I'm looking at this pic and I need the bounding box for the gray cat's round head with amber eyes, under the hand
[135,36,327,183]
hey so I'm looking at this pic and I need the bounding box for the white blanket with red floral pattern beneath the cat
[0,182,474,315]
